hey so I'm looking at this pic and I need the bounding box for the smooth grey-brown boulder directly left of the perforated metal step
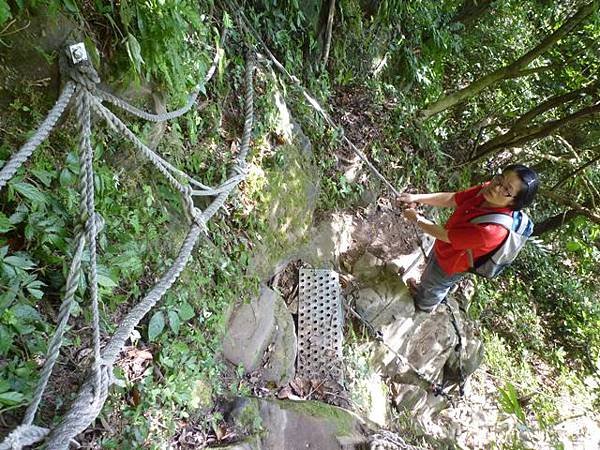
[223,287,296,386]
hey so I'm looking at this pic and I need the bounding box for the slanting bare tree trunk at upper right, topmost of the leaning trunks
[419,0,598,120]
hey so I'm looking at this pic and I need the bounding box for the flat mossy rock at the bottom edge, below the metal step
[221,398,368,450]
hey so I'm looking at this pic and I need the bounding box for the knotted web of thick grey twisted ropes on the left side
[0,38,254,450]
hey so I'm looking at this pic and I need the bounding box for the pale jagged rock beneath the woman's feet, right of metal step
[352,252,483,419]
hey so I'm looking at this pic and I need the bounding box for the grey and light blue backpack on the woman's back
[467,211,533,278]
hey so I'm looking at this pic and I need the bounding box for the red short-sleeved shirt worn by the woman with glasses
[434,183,512,275]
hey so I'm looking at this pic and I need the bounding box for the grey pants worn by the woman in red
[415,250,466,312]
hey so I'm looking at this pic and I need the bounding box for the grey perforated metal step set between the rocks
[296,269,344,382]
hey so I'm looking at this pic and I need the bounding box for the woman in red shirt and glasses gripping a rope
[398,164,539,312]
